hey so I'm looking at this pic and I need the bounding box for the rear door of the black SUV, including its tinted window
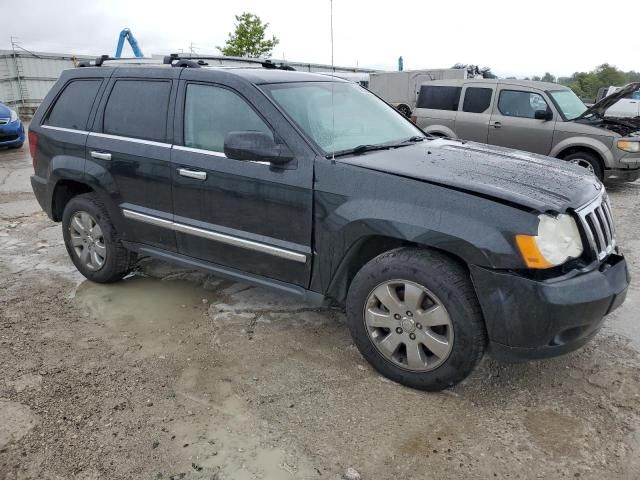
[87,68,180,251]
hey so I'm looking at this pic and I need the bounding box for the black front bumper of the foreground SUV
[471,254,630,361]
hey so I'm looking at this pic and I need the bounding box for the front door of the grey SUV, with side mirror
[488,85,558,155]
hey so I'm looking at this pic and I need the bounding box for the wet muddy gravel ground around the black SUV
[0,143,640,480]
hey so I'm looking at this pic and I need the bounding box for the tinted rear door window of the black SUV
[103,80,171,142]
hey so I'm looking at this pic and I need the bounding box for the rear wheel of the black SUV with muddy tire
[62,193,134,283]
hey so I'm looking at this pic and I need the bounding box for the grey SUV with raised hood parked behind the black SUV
[412,79,640,181]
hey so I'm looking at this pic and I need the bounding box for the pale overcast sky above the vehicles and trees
[0,0,640,77]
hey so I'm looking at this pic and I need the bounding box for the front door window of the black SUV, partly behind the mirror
[184,84,273,152]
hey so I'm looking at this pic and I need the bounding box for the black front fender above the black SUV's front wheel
[311,159,538,293]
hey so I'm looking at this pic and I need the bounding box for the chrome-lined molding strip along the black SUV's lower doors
[122,208,307,263]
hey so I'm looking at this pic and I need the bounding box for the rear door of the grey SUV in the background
[455,83,496,143]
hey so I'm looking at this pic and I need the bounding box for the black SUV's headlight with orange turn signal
[516,214,583,268]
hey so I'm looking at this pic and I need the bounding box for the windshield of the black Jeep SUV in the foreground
[262,82,424,155]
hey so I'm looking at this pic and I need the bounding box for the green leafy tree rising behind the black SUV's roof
[216,12,280,58]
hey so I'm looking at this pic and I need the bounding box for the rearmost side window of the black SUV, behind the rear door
[44,79,102,130]
